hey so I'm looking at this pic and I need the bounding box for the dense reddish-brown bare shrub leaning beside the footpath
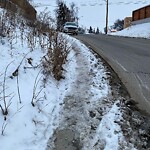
[43,32,70,81]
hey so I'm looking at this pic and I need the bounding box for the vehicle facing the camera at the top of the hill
[63,22,78,35]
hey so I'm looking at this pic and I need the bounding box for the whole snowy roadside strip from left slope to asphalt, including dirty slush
[46,37,150,150]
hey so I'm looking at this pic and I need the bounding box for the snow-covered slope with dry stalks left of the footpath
[0,9,76,150]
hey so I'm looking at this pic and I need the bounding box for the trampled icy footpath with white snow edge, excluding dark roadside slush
[46,41,123,150]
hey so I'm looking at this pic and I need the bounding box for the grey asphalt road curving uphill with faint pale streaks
[76,34,150,114]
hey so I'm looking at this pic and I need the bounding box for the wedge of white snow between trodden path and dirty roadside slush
[91,102,123,150]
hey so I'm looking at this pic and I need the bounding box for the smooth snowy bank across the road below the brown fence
[110,23,150,39]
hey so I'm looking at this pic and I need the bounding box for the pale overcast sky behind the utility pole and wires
[34,0,150,31]
